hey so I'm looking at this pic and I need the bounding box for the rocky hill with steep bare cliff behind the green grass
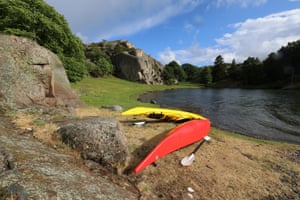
[87,40,163,85]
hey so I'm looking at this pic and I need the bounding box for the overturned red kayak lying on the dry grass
[134,119,210,173]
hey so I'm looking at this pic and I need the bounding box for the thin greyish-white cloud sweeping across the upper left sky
[46,0,202,41]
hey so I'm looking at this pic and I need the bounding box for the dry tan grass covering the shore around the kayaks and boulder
[8,107,300,200]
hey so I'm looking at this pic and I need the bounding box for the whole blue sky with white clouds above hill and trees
[46,0,300,66]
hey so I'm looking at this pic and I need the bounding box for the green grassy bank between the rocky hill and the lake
[72,77,201,109]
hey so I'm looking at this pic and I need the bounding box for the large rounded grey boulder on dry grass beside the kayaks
[58,117,130,174]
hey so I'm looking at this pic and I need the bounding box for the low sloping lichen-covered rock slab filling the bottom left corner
[0,134,138,200]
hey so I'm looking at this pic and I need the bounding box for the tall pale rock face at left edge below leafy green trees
[0,34,82,108]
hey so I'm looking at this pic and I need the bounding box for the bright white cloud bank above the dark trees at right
[159,9,300,64]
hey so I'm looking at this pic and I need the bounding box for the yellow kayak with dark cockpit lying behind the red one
[122,107,206,122]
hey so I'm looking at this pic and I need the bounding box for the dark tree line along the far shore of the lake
[163,40,300,87]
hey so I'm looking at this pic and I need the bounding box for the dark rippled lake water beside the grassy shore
[141,89,300,144]
